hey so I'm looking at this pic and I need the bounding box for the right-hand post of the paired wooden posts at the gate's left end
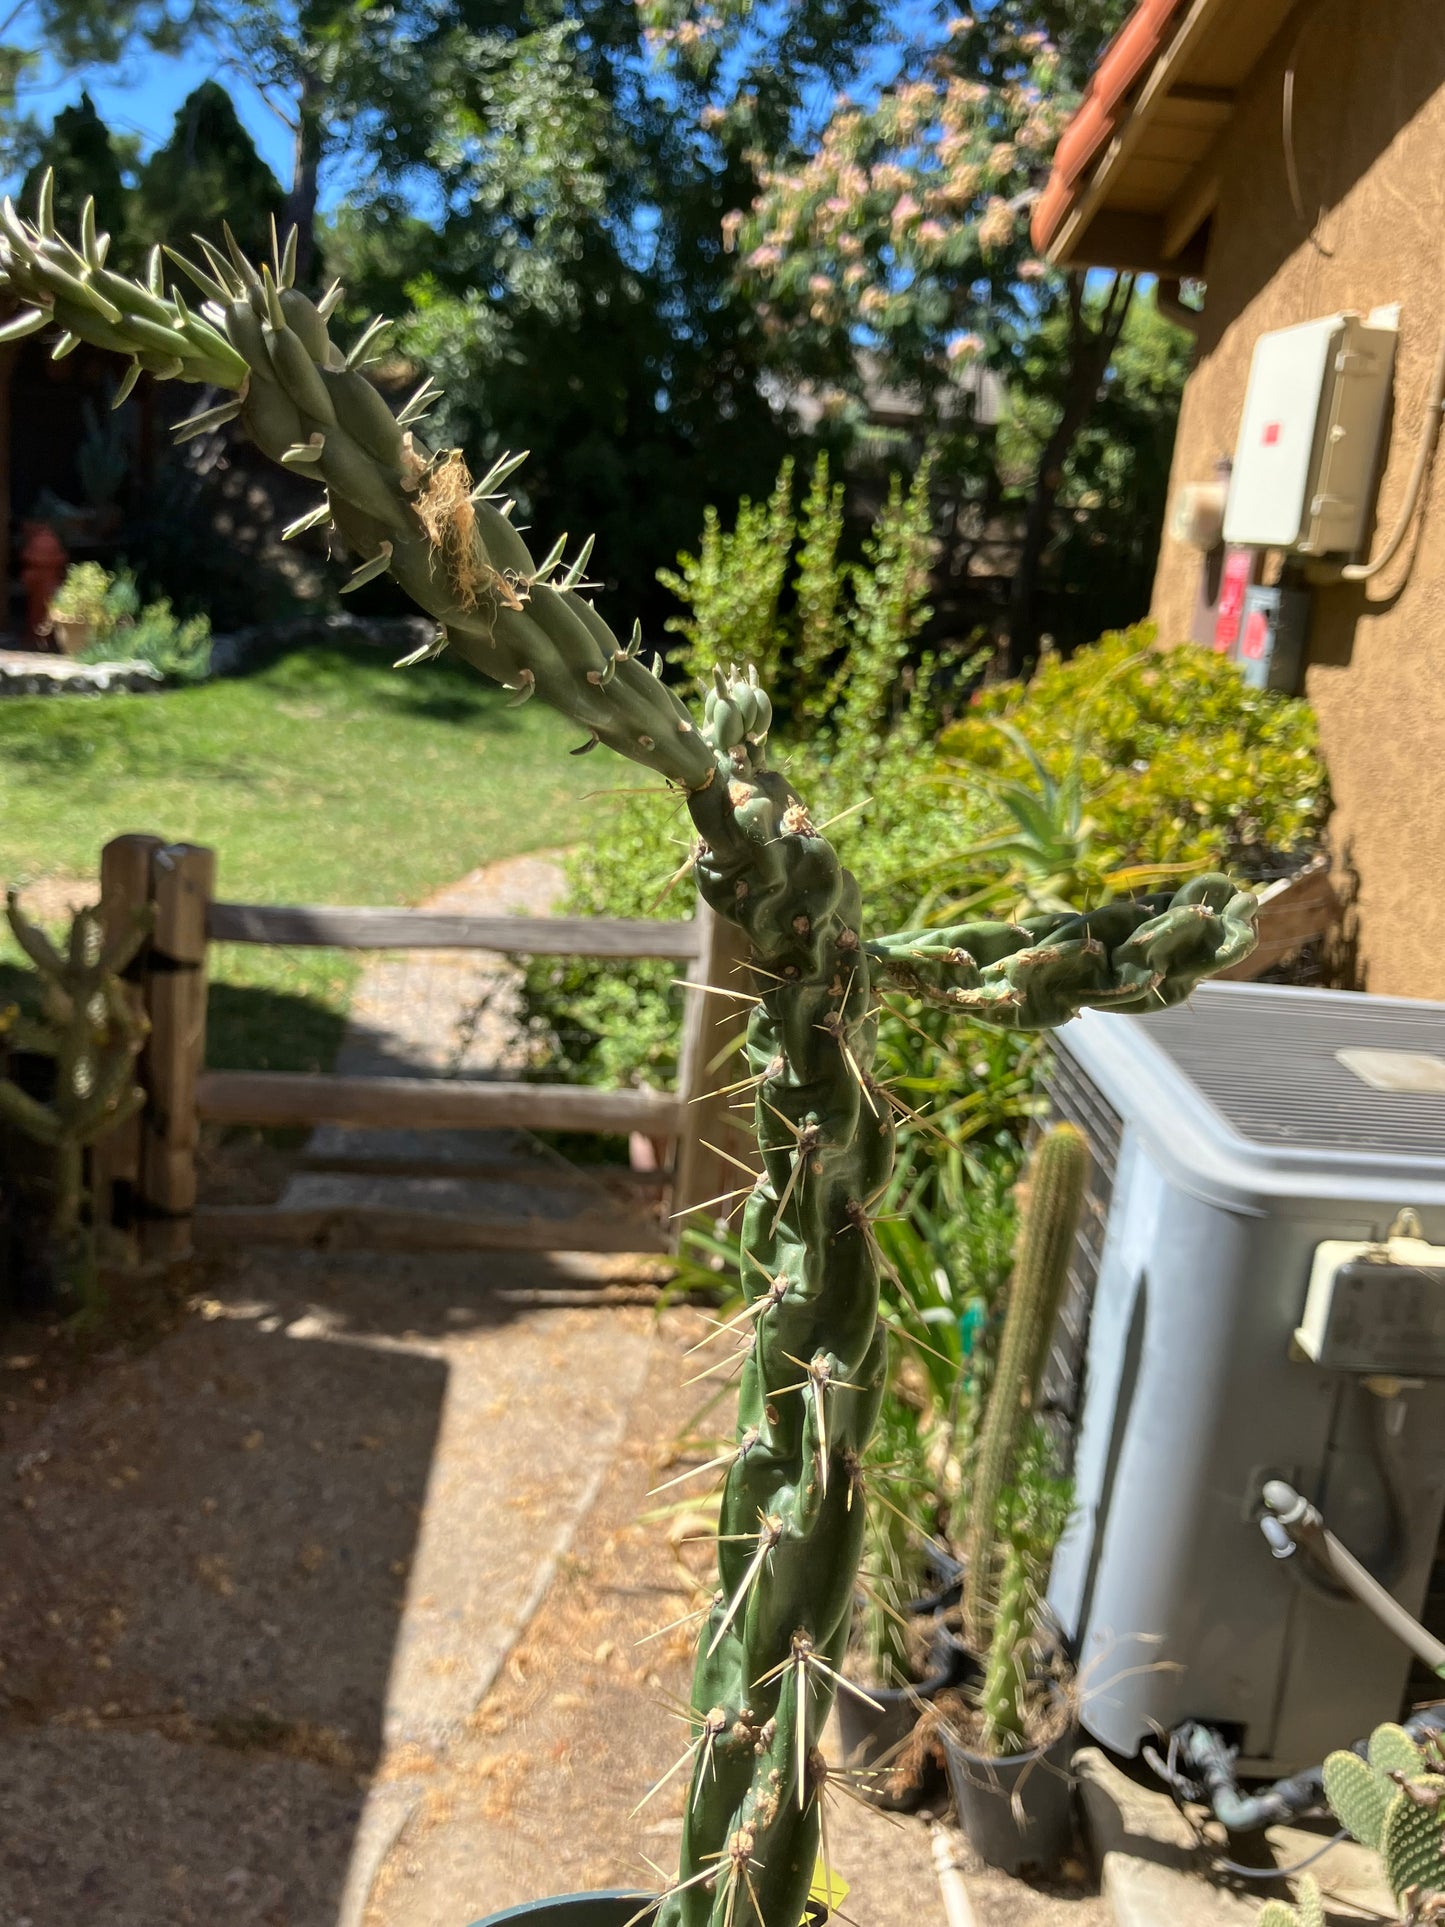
[141,844,216,1258]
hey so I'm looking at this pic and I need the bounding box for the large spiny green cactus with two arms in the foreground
[0,189,1254,1927]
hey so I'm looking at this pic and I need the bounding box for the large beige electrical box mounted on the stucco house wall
[1223,314,1397,561]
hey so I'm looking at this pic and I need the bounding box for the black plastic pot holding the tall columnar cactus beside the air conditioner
[942,1694,1075,1873]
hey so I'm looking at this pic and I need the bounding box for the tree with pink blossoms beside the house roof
[647,0,1179,671]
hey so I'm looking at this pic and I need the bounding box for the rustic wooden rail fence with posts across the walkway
[92,836,744,1256]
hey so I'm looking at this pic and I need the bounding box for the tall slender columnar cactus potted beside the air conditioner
[963,1123,1089,1650]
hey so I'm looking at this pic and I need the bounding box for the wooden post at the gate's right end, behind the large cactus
[672,898,757,1243]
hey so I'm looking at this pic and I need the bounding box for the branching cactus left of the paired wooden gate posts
[0,890,146,1299]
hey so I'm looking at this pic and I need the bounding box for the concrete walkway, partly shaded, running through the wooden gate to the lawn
[0,859,653,1927]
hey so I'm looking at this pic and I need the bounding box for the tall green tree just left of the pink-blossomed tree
[326,0,882,617]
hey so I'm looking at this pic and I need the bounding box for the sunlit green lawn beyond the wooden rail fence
[0,647,626,1069]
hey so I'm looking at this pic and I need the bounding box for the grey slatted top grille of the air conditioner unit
[1125,985,1445,1158]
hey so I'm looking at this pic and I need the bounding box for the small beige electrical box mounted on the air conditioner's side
[1295,1237,1445,1378]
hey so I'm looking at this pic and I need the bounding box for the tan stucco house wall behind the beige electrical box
[1152,0,1445,998]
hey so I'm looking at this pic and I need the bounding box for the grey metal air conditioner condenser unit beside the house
[1044,985,1445,1775]
